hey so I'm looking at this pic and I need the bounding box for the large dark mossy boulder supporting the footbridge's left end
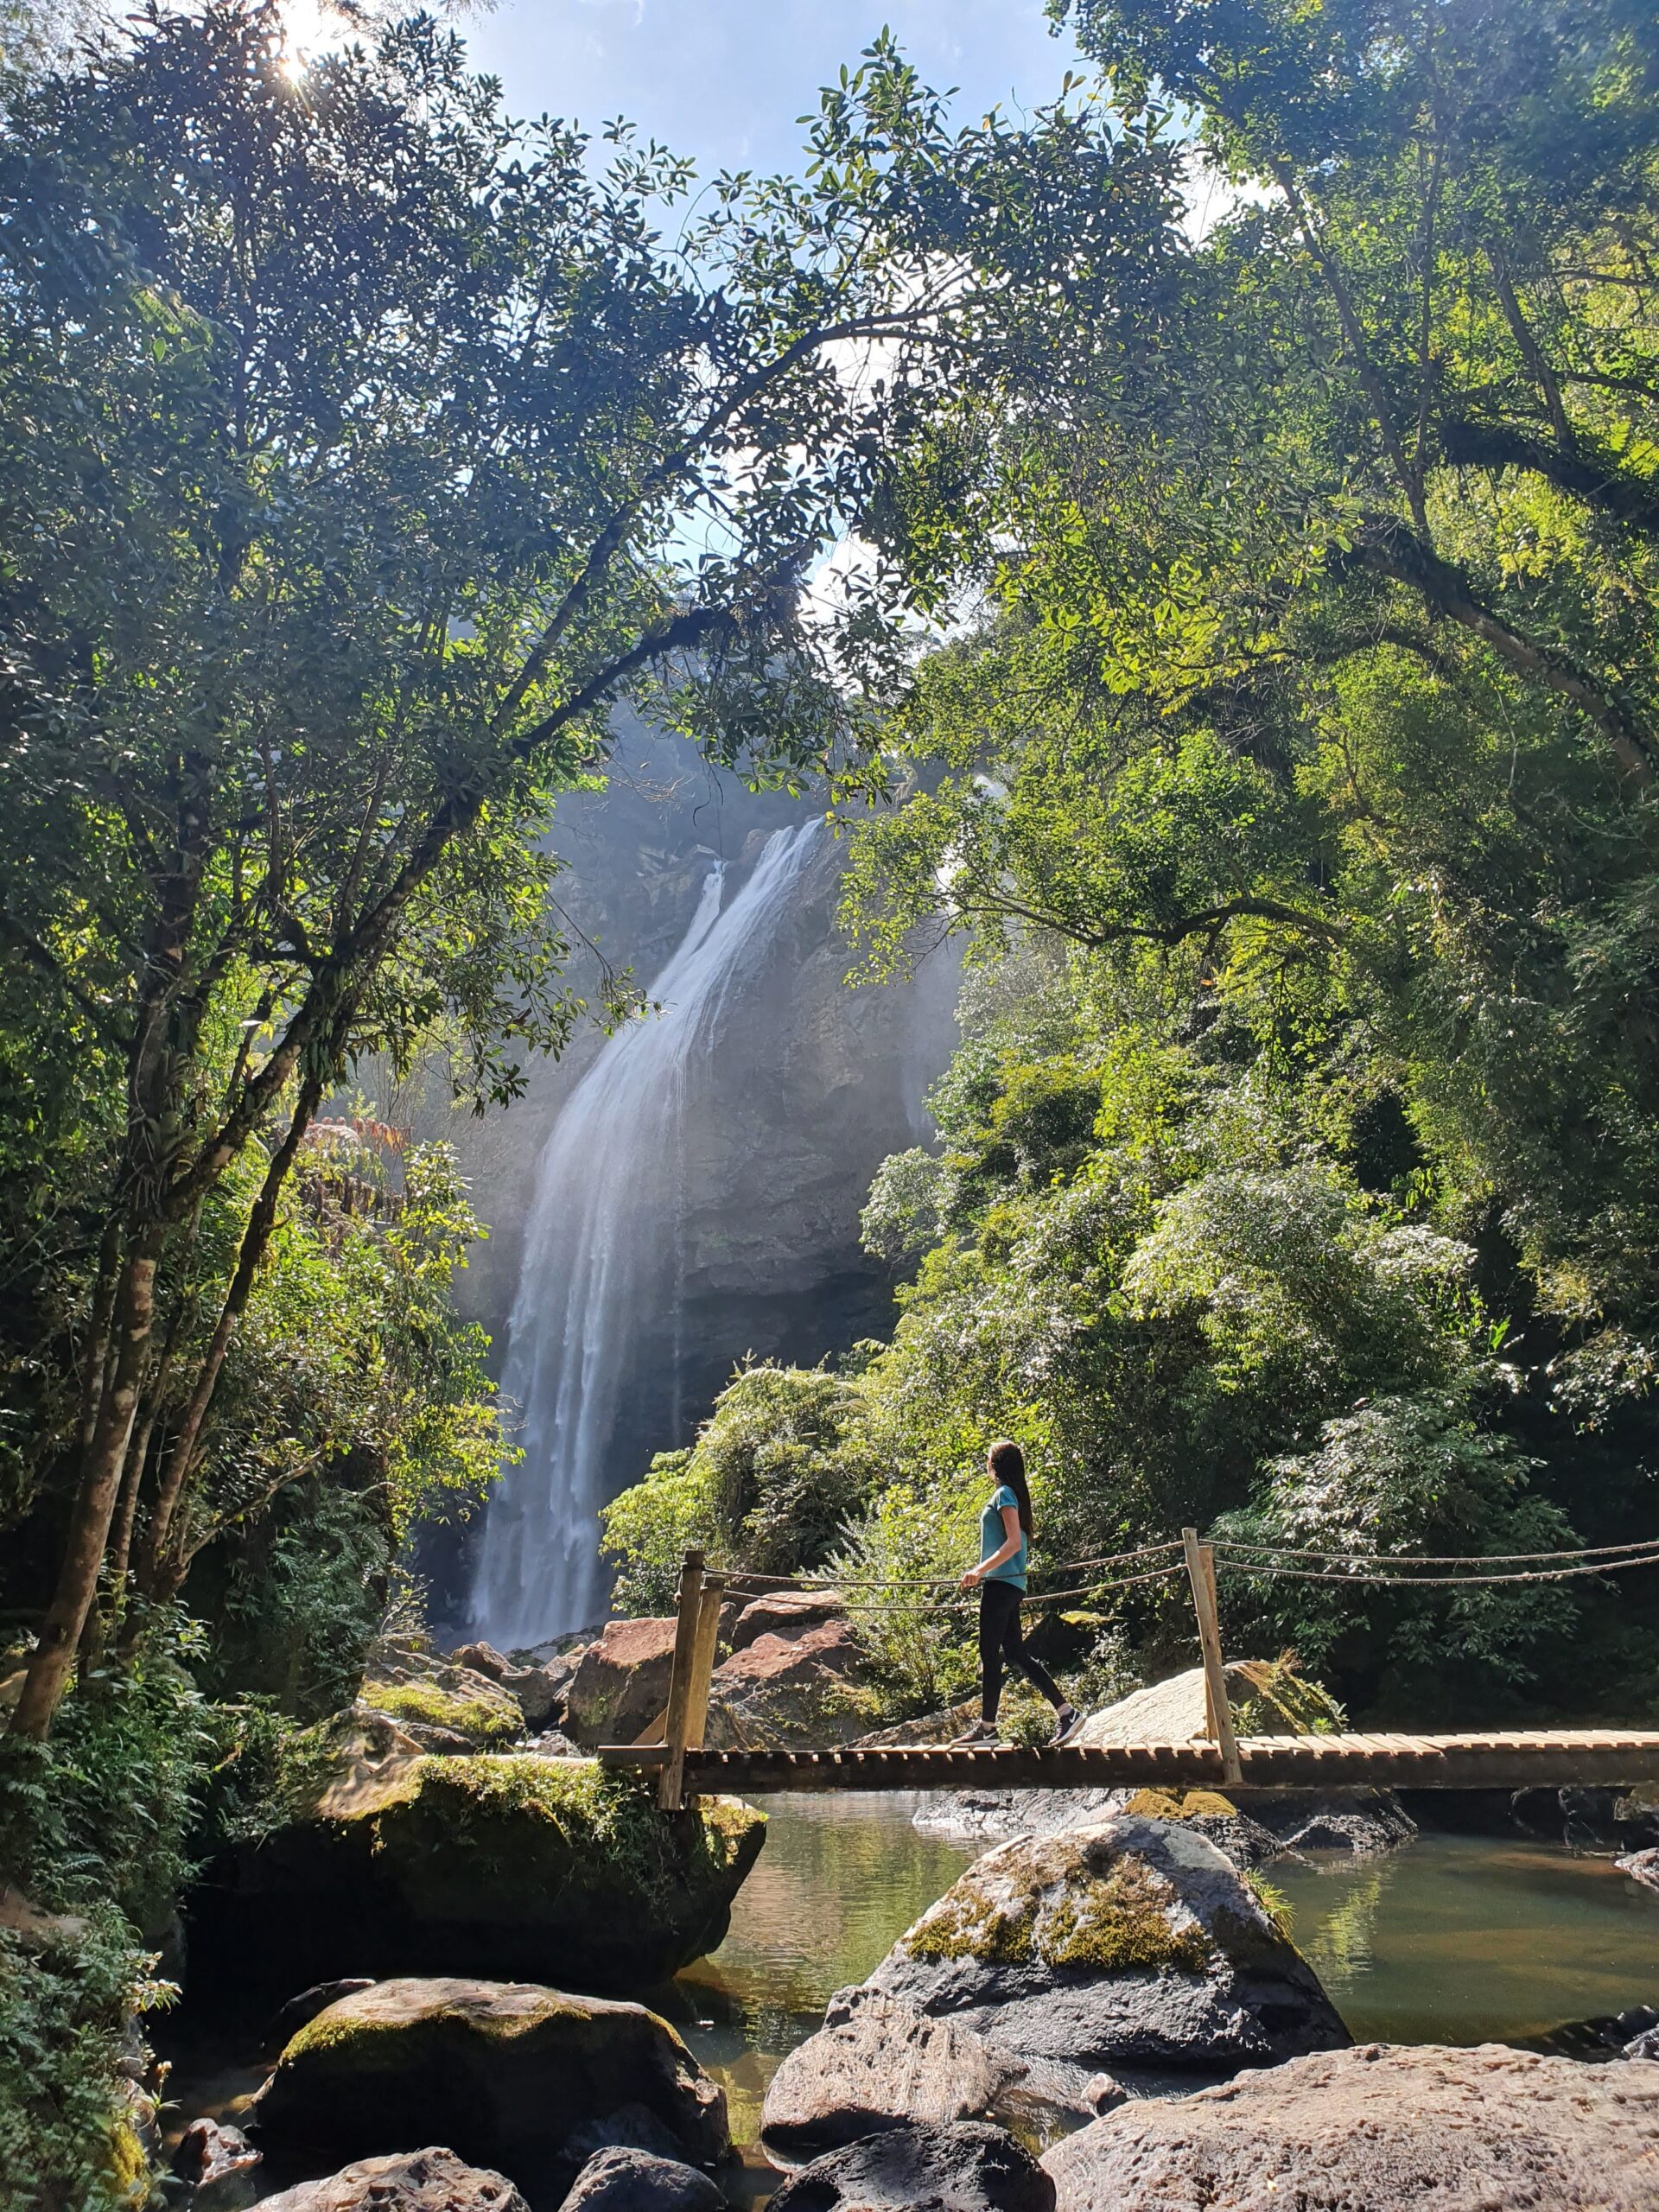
[194,1754,766,1988]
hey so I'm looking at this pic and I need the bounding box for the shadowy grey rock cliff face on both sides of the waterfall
[403,730,956,1626]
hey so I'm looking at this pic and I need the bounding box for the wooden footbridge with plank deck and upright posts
[600,1529,1659,1809]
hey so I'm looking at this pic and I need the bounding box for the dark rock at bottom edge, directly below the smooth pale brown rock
[772,2119,1055,2212]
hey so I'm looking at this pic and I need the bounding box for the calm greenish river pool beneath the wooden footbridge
[157,1794,1659,2205]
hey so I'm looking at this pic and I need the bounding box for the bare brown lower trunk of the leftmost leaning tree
[11,1225,162,1743]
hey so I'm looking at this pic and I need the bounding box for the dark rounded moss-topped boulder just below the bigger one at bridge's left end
[254,1980,730,2181]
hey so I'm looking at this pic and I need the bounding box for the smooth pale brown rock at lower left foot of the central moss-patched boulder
[761,1988,1024,2165]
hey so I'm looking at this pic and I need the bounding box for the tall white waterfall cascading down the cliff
[474,823,818,1650]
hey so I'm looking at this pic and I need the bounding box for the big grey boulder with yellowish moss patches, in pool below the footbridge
[872,1816,1350,2113]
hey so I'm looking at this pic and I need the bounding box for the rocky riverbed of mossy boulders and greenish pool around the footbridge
[159,1637,1659,2212]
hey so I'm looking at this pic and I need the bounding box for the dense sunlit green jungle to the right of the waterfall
[608,0,1659,1719]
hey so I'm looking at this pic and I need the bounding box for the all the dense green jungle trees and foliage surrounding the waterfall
[0,0,1659,2212]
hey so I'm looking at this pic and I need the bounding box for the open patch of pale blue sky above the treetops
[462,0,1075,175]
